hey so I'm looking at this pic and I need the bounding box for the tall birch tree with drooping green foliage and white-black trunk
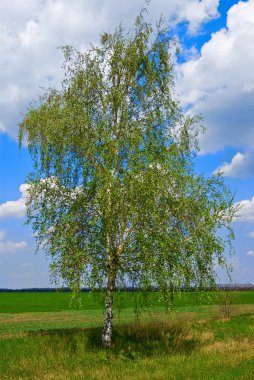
[19,12,235,347]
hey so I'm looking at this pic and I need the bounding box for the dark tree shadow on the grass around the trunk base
[30,321,199,360]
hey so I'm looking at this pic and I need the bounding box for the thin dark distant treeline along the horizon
[0,284,254,293]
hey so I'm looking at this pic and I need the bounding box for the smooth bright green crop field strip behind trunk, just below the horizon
[0,291,254,313]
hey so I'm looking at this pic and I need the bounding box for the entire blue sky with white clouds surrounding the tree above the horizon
[0,0,254,288]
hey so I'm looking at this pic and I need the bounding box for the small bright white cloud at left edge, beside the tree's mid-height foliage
[0,184,28,218]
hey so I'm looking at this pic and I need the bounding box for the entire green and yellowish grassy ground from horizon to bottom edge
[0,291,254,380]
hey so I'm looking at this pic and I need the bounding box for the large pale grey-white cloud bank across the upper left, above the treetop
[0,0,219,137]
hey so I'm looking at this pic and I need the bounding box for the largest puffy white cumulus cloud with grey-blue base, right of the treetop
[177,0,254,153]
